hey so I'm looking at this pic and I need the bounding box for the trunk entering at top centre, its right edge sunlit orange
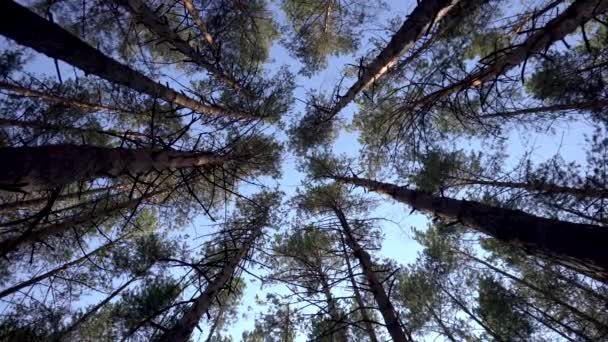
[331,0,459,115]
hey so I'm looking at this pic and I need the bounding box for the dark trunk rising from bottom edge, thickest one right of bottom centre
[332,207,412,342]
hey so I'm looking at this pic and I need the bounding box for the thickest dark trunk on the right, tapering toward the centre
[332,177,608,283]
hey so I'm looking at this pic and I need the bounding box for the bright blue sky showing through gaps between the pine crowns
[1,0,590,341]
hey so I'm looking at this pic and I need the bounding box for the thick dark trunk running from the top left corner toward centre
[0,0,246,118]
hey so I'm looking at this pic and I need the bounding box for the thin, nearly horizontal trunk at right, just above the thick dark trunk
[454,177,608,198]
